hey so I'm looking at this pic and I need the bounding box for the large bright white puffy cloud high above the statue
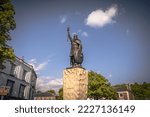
[86,5,118,28]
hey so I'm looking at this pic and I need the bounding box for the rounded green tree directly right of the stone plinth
[88,71,117,100]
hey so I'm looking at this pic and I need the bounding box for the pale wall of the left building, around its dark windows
[0,58,37,99]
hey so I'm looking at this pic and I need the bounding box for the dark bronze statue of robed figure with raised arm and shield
[67,27,83,67]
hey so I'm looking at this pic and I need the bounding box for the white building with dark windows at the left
[0,57,37,100]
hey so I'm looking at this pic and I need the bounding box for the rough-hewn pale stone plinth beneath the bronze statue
[63,68,88,100]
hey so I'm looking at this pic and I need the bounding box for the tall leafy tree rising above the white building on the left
[0,0,16,69]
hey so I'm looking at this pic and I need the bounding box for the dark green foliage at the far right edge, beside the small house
[131,82,150,100]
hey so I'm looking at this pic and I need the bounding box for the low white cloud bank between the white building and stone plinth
[36,76,63,92]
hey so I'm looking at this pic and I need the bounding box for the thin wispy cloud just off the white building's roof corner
[29,59,50,72]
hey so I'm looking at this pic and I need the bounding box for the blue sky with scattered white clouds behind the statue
[10,0,150,91]
